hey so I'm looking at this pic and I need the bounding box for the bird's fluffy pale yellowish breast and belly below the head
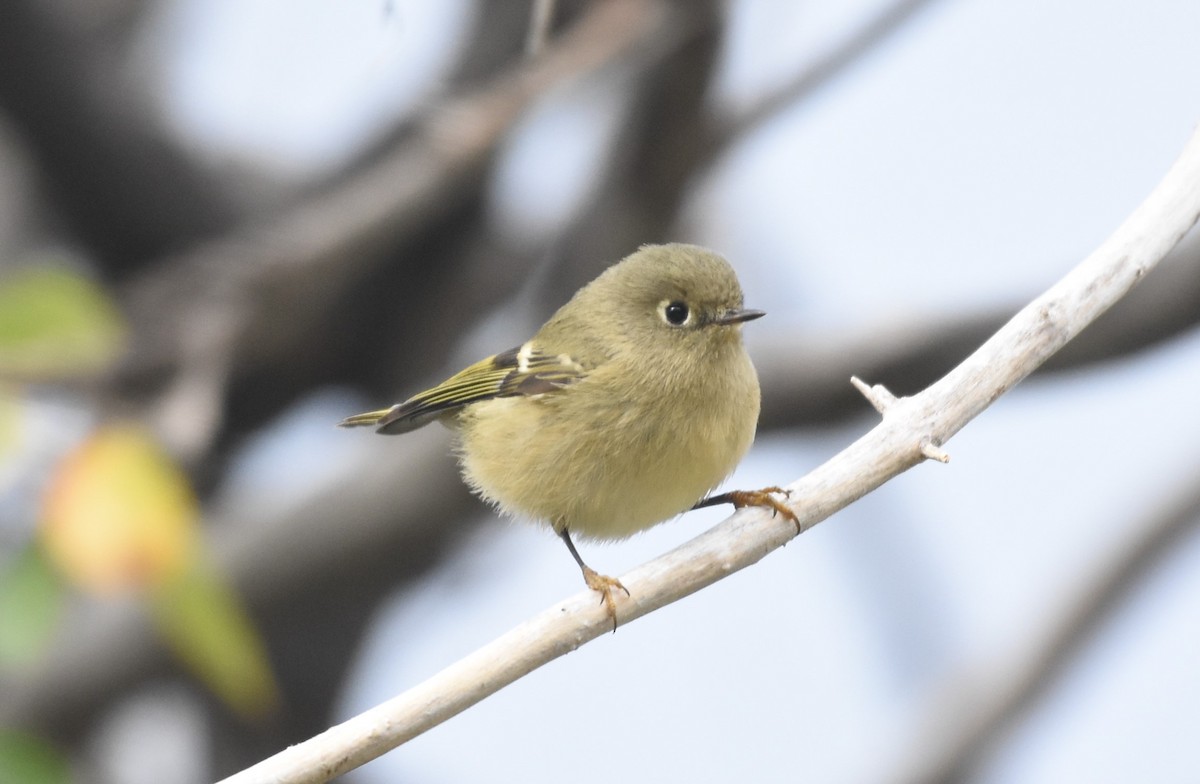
[460,348,758,539]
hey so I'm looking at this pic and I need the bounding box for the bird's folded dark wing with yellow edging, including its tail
[340,342,587,435]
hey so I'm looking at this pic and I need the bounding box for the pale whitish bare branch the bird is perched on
[226,125,1200,784]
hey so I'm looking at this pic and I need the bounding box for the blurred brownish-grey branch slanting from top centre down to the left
[119,0,688,457]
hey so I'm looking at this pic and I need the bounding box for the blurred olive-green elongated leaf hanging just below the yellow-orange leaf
[151,563,278,719]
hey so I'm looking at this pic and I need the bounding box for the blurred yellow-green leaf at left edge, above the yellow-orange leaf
[0,267,125,381]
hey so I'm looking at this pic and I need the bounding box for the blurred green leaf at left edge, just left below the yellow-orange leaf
[0,545,62,667]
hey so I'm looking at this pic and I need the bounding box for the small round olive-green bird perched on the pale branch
[341,244,796,629]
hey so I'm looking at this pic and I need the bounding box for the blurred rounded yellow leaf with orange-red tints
[41,425,198,594]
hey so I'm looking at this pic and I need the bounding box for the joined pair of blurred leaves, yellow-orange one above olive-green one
[41,425,277,717]
